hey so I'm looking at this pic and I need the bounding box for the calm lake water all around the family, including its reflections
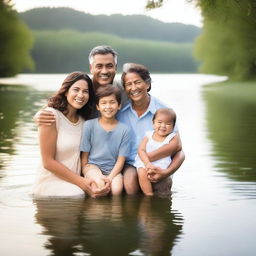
[0,74,256,256]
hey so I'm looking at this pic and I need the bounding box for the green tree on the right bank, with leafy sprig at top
[147,0,256,80]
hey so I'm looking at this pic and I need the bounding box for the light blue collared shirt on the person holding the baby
[117,96,178,164]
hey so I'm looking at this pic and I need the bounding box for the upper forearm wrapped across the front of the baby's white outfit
[147,133,182,162]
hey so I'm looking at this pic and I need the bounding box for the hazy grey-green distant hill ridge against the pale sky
[19,8,201,43]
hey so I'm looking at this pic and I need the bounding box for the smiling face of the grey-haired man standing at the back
[90,53,116,86]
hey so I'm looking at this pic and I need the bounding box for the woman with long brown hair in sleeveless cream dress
[33,71,108,198]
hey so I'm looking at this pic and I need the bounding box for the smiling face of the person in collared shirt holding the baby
[124,73,149,102]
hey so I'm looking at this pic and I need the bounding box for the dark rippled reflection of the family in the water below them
[34,196,183,256]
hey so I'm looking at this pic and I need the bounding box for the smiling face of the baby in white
[153,113,173,137]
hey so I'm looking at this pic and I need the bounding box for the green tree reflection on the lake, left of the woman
[0,84,49,169]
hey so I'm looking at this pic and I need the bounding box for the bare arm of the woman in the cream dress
[39,124,88,191]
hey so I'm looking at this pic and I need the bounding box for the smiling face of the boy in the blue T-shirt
[96,94,121,119]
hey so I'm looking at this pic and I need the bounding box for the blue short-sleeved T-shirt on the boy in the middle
[80,118,130,174]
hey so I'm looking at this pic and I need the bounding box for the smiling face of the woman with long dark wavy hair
[66,80,89,109]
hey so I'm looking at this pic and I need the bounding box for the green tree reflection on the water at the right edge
[204,84,256,198]
